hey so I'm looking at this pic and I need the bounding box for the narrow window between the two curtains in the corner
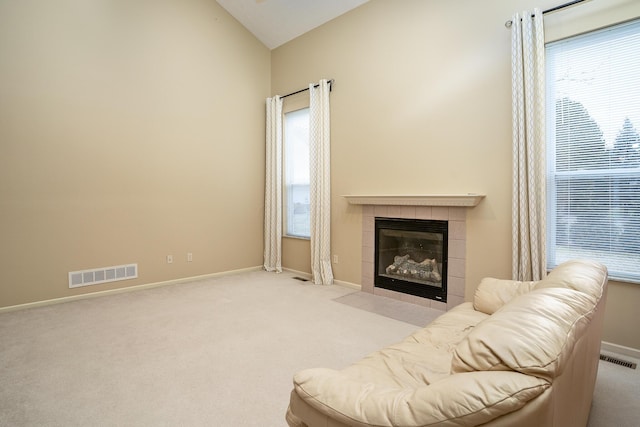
[284,108,311,238]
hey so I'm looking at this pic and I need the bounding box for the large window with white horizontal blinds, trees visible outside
[546,20,640,283]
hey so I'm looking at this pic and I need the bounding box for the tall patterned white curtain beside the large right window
[511,9,546,280]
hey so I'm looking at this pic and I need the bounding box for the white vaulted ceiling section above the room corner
[216,0,369,49]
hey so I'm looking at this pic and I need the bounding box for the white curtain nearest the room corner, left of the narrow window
[264,96,282,273]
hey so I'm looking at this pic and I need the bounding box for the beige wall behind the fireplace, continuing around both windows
[271,0,640,349]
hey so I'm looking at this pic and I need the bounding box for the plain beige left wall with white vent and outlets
[0,0,270,307]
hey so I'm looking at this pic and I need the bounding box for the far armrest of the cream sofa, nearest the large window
[473,277,538,315]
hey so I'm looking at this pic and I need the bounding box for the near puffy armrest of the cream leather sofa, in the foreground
[294,368,550,427]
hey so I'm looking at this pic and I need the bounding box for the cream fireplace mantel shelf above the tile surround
[343,193,485,207]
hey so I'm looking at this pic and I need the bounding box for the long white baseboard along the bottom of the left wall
[0,266,263,313]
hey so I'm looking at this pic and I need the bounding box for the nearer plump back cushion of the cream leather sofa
[451,288,597,380]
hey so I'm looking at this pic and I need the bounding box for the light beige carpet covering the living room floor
[0,271,640,427]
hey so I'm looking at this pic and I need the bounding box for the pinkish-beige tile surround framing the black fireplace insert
[361,203,467,311]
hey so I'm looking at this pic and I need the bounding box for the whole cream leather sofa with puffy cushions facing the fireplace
[286,261,607,427]
